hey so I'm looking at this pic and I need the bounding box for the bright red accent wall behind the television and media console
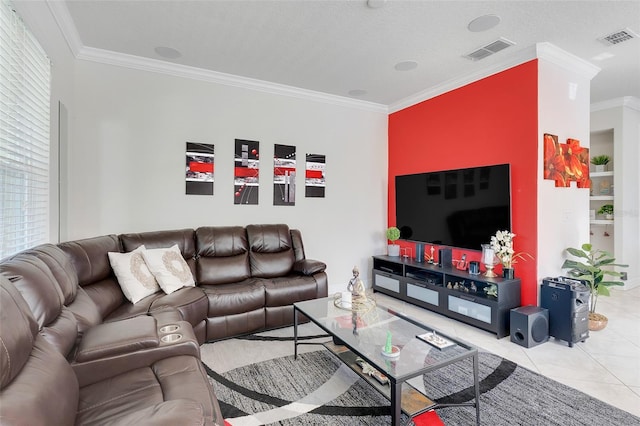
[388,60,538,305]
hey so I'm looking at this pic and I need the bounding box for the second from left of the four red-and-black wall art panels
[233,139,260,204]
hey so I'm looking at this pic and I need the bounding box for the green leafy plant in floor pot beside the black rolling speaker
[562,243,629,331]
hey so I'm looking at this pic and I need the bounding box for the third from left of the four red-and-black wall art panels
[273,144,296,206]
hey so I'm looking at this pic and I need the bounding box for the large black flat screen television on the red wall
[395,164,511,250]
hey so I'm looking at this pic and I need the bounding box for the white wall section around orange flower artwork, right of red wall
[537,45,592,286]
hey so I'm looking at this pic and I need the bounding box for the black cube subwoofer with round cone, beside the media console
[510,306,549,348]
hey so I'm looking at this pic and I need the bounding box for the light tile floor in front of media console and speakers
[375,287,640,416]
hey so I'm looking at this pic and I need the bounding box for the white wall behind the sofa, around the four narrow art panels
[69,61,387,293]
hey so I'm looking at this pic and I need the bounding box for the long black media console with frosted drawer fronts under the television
[373,256,520,338]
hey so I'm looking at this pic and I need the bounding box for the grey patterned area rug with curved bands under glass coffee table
[202,328,640,426]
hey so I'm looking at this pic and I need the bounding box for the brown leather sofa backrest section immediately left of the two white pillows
[58,235,124,319]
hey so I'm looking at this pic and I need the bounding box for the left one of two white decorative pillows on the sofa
[108,246,160,303]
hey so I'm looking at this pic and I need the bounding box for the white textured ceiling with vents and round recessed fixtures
[25,0,640,105]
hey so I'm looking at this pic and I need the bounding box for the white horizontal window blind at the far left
[0,0,51,258]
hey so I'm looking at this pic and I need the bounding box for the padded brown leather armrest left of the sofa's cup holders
[75,316,160,363]
